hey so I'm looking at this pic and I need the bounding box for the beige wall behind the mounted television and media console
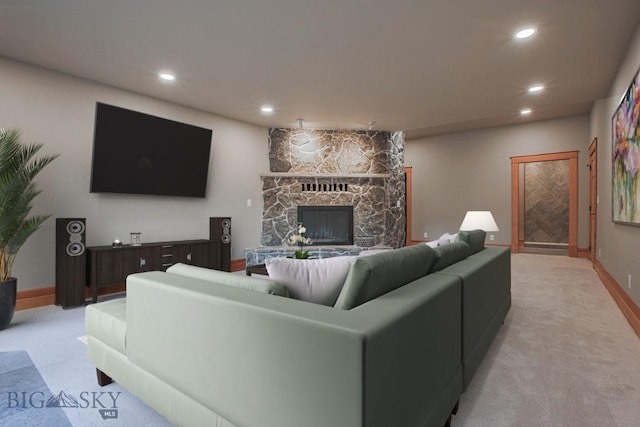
[0,59,269,290]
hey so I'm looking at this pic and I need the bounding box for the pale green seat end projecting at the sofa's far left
[85,298,127,354]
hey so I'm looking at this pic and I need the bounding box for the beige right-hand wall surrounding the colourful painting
[591,26,640,306]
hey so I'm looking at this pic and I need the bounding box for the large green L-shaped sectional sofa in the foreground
[86,234,510,427]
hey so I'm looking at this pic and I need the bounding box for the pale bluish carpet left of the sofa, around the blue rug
[0,306,172,427]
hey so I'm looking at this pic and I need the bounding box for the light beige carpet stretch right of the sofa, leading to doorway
[452,254,640,427]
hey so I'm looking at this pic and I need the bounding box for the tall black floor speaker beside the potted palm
[55,218,87,308]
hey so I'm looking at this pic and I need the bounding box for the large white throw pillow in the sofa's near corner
[265,256,355,306]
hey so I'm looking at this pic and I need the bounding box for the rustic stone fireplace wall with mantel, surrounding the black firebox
[262,129,406,247]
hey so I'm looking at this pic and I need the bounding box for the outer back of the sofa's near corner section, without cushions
[127,272,461,427]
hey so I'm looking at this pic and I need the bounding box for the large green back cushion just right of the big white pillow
[335,245,435,310]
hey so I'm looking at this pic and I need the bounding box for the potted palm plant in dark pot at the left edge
[0,129,57,330]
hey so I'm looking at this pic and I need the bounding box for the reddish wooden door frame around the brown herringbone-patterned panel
[511,151,579,257]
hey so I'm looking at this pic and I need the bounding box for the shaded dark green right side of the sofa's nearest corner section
[351,274,463,427]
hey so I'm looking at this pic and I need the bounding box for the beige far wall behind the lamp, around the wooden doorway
[405,116,590,248]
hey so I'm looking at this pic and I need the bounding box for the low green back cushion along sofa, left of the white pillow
[167,263,289,297]
